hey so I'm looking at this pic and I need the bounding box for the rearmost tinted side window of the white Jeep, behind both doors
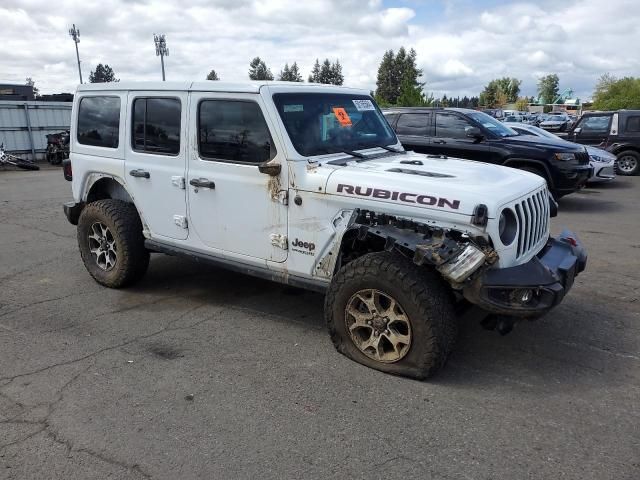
[78,97,120,148]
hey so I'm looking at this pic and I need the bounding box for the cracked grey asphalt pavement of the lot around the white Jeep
[0,169,640,480]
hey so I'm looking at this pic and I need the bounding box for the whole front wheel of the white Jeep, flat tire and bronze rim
[325,252,457,379]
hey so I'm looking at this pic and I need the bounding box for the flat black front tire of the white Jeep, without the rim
[324,252,458,380]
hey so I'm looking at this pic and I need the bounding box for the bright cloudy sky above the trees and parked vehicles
[0,0,640,100]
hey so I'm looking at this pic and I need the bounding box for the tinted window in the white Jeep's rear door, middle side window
[131,98,181,155]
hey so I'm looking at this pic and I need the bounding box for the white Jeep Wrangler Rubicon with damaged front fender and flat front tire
[64,82,586,378]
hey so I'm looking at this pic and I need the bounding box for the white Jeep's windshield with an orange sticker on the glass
[273,93,398,157]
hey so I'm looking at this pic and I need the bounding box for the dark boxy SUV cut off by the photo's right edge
[569,110,640,175]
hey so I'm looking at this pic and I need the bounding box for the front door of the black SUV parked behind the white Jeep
[431,112,492,162]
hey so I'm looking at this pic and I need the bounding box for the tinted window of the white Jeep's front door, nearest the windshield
[198,100,276,163]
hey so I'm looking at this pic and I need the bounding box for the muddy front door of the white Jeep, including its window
[187,92,287,262]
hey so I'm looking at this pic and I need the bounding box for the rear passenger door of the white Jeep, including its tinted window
[125,92,188,240]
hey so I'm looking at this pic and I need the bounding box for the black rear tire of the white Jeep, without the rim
[78,200,149,288]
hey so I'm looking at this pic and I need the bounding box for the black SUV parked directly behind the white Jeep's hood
[384,107,591,198]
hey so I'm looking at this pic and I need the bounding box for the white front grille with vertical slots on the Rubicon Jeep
[514,188,549,259]
